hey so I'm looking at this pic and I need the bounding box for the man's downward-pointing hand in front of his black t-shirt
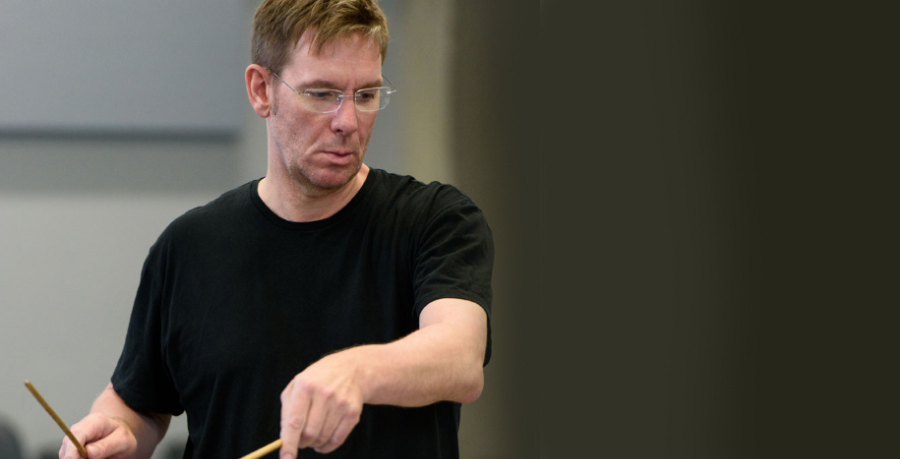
[282,351,364,459]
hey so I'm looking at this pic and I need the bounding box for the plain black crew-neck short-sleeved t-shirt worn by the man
[112,169,493,459]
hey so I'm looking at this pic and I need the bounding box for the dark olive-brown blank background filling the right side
[472,1,898,458]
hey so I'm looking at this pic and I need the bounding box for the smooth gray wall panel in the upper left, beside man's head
[0,0,249,135]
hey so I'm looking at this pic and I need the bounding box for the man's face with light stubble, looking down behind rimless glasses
[267,31,382,196]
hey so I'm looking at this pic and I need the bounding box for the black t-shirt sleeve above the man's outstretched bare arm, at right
[414,187,494,365]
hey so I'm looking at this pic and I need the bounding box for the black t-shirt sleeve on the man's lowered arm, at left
[111,236,184,415]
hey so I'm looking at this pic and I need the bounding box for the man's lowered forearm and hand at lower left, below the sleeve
[59,383,172,459]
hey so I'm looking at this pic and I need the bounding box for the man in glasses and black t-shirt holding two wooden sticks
[60,0,493,459]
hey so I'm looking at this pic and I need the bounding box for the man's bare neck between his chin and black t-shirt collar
[258,164,369,222]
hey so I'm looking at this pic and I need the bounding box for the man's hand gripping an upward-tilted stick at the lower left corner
[59,413,137,459]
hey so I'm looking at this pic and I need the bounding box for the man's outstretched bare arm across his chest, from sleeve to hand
[281,298,487,459]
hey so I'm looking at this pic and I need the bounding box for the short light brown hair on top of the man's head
[250,0,390,73]
